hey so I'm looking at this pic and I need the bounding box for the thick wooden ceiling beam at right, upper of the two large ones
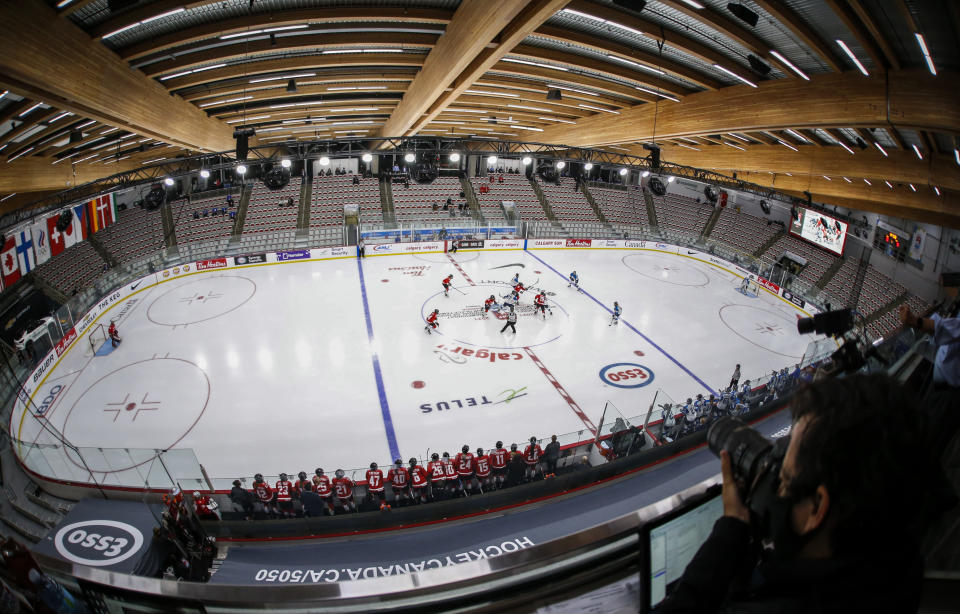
[541,70,960,146]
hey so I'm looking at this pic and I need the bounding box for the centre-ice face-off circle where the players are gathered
[420,283,570,350]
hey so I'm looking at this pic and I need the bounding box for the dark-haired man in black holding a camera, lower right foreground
[657,376,941,614]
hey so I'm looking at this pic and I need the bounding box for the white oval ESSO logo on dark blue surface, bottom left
[53,520,143,567]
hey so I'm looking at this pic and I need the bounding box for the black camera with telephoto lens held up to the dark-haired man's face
[707,417,790,539]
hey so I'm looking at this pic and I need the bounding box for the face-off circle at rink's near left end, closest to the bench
[63,358,210,473]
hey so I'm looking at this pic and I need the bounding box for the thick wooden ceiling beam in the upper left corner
[0,2,234,151]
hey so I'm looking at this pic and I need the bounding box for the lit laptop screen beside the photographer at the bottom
[648,493,723,608]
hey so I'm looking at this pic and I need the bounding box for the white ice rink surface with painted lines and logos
[10,248,812,488]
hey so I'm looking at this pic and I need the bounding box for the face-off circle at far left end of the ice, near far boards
[147,275,257,326]
